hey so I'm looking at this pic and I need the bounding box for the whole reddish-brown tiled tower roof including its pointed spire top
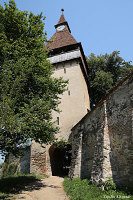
[47,14,77,50]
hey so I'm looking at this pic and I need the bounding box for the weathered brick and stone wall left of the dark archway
[8,141,47,174]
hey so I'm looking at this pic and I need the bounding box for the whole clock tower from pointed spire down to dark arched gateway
[30,9,90,175]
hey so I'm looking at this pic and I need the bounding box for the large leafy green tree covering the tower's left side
[0,0,67,155]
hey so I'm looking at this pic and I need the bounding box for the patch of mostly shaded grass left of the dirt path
[0,174,46,200]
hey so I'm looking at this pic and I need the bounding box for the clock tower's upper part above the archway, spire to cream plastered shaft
[48,9,90,140]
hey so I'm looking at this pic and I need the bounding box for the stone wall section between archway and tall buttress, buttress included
[69,102,112,184]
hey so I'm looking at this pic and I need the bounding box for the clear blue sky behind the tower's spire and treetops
[0,0,133,162]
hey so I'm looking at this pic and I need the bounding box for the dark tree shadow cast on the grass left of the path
[0,175,46,195]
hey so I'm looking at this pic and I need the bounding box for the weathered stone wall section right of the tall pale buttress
[107,73,133,186]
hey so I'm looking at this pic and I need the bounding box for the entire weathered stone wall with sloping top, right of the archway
[69,73,133,189]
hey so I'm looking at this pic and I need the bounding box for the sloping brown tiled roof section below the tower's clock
[47,27,77,50]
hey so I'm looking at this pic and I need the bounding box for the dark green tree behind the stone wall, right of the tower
[87,51,133,107]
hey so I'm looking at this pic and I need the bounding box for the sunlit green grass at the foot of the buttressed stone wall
[64,178,133,200]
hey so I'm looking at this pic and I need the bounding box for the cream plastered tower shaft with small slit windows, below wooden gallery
[53,60,90,140]
